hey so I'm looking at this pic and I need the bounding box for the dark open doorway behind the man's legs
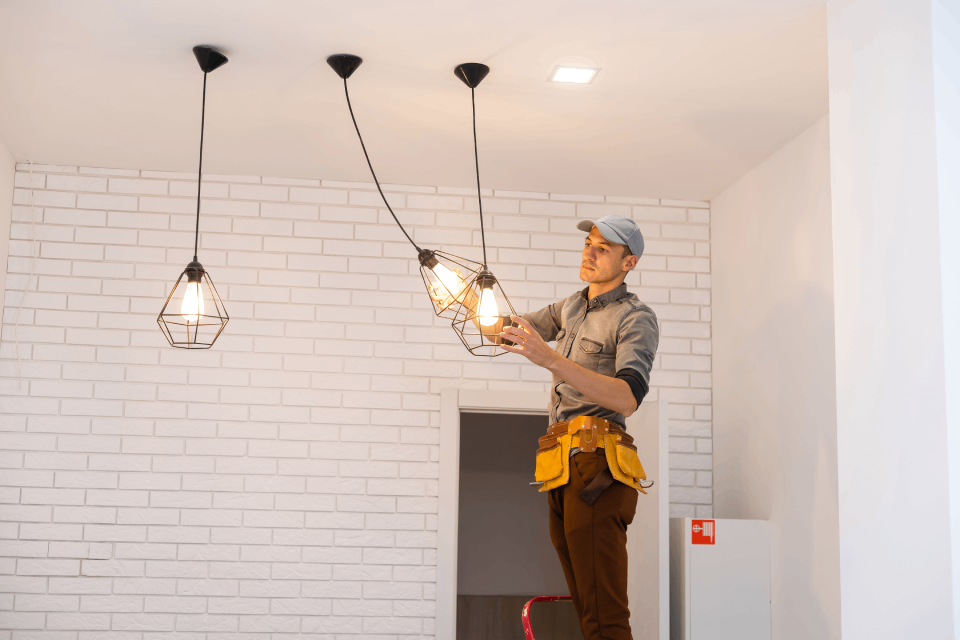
[456,412,583,640]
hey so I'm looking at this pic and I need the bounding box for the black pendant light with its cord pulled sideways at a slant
[327,53,483,320]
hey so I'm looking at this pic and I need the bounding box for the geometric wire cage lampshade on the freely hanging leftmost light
[157,261,230,349]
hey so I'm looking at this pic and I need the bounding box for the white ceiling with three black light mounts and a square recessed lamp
[0,0,827,200]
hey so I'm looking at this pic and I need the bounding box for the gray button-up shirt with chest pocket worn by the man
[523,284,660,426]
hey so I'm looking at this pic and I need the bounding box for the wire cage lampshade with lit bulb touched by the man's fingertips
[452,269,517,357]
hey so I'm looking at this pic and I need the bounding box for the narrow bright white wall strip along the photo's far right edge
[931,0,960,636]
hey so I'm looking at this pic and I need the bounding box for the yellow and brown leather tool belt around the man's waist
[534,416,647,504]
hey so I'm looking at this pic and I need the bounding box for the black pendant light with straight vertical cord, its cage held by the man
[444,62,516,356]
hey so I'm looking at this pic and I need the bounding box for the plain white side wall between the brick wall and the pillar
[711,118,840,640]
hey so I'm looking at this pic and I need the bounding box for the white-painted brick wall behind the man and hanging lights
[0,165,712,640]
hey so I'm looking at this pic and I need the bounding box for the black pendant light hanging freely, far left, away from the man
[157,45,230,349]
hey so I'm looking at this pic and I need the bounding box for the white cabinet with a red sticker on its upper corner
[670,518,771,640]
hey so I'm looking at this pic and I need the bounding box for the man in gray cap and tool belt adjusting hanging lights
[501,216,660,640]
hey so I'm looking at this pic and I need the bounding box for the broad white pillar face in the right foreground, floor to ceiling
[828,0,956,638]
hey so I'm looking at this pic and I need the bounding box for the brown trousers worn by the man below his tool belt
[548,449,638,640]
